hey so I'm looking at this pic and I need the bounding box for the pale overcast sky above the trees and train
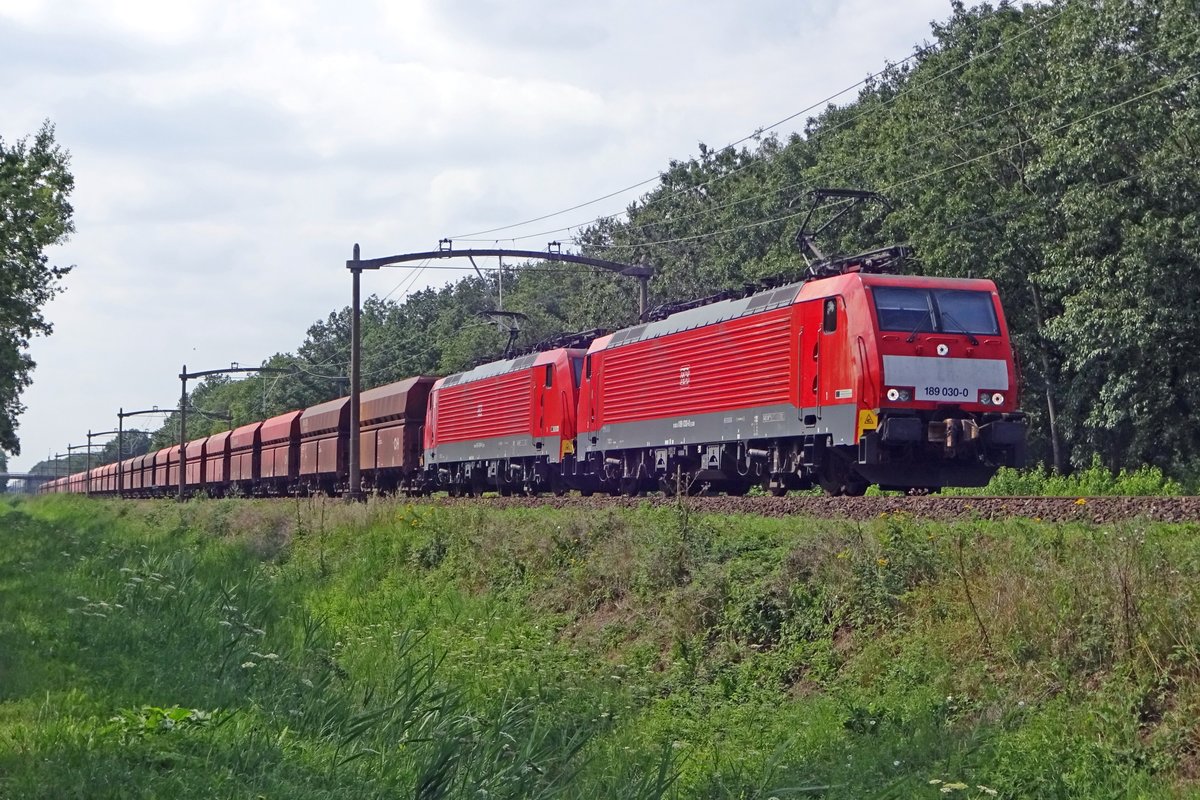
[0,0,950,468]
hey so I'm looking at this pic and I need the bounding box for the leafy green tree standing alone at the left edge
[0,122,74,455]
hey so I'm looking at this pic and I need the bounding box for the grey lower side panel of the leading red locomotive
[580,403,858,453]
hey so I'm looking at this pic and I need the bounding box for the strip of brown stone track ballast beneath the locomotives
[443,495,1200,523]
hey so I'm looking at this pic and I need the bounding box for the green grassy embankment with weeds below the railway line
[0,497,1200,800]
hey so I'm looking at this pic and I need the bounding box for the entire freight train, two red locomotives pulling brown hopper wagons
[43,251,1026,497]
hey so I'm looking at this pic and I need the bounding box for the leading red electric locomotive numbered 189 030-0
[578,260,1025,494]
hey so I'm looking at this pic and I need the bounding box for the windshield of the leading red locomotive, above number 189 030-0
[871,287,1000,336]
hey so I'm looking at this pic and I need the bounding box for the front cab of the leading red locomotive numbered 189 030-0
[854,275,1025,488]
